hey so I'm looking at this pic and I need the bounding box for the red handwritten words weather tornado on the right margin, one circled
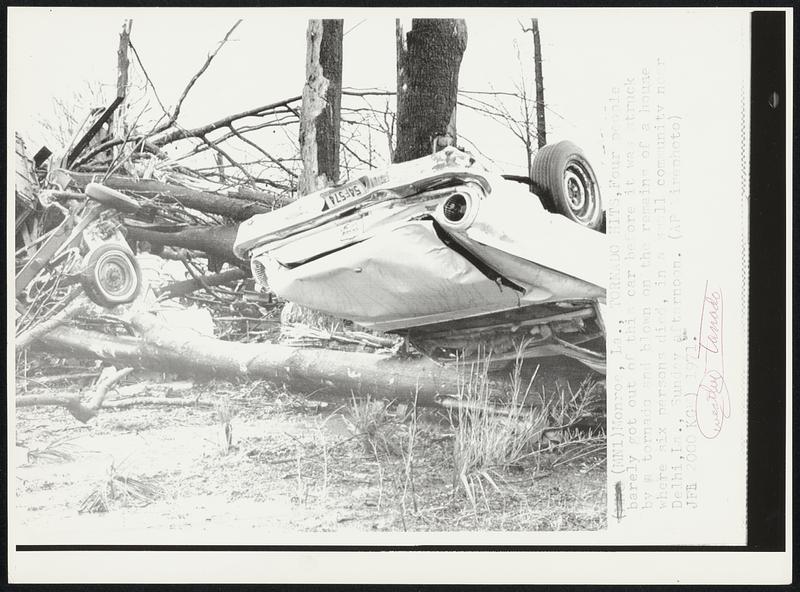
[695,282,731,439]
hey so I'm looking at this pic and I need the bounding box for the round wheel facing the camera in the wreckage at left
[81,244,142,308]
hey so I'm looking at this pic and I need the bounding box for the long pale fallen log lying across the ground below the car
[32,313,482,405]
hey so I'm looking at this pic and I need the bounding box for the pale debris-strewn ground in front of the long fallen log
[11,374,606,544]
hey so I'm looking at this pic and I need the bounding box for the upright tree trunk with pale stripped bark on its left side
[299,19,343,195]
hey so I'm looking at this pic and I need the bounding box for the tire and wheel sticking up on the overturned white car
[531,141,604,230]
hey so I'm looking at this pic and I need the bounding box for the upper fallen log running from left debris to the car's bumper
[66,171,273,220]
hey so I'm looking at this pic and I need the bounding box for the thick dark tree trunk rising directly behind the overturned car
[394,19,467,162]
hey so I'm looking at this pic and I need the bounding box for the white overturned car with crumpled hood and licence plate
[234,142,606,372]
